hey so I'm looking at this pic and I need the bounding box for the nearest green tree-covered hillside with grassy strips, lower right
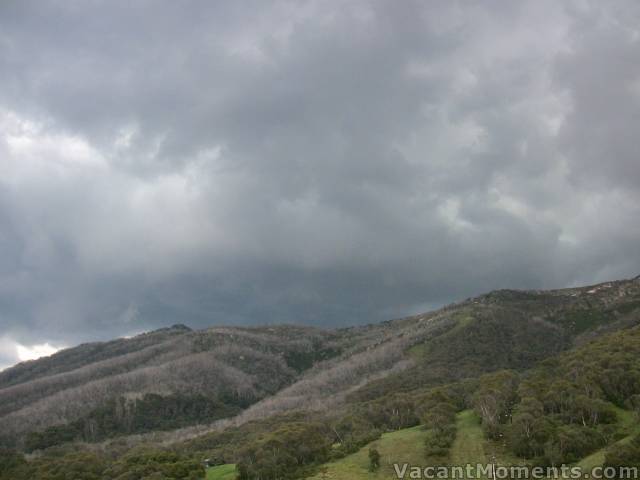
[302,320,640,480]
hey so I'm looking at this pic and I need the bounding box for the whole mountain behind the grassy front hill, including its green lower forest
[0,277,640,478]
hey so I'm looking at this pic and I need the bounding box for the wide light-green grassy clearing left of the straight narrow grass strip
[304,427,425,480]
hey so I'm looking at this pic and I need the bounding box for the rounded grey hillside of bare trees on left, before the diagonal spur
[0,326,340,446]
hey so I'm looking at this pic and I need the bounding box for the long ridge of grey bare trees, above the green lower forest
[0,276,640,456]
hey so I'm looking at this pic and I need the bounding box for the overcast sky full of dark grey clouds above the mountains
[0,0,640,368]
